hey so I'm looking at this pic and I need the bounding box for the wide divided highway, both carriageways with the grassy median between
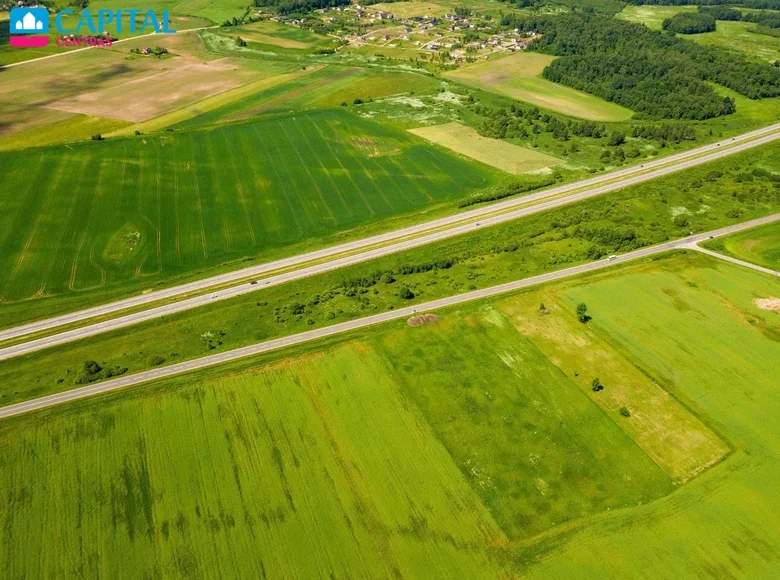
[0,124,780,360]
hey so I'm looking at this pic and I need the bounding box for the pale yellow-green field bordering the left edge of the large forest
[444,52,633,121]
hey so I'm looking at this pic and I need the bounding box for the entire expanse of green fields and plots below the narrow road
[0,252,780,579]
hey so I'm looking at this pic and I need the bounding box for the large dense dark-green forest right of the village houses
[502,13,780,119]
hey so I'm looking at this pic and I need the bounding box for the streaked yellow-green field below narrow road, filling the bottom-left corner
[0,346,504,578]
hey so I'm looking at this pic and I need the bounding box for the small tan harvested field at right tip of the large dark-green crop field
[409,123,563,175]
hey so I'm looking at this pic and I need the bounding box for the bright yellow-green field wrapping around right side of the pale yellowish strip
[517,254,780,579]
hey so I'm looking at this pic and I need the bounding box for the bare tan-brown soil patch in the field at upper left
[47,59,246,123]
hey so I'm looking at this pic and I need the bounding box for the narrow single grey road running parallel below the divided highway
[0,213,780,419]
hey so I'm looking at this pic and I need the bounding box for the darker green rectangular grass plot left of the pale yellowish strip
[376,306,676,540]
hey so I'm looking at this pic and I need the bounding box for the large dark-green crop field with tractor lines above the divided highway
[0,111,493,301]
